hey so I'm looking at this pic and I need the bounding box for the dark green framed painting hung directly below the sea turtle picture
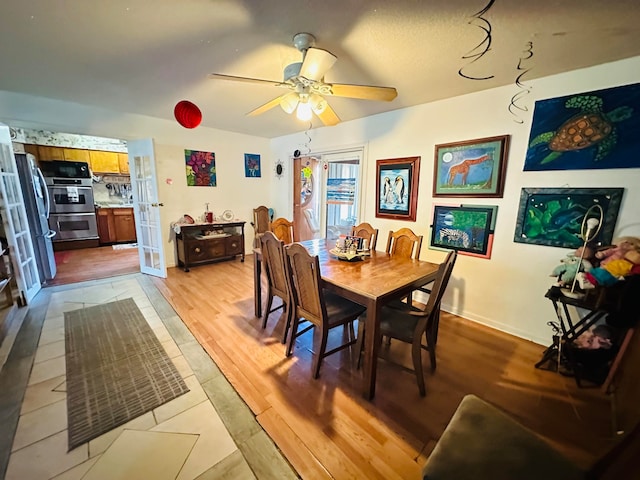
[513,188,624,248]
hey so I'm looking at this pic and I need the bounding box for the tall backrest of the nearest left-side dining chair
[285,243,327,328]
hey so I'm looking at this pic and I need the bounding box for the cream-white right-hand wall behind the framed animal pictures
[271,57,640,344]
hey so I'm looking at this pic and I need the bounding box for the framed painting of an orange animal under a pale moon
[433,135,509,198]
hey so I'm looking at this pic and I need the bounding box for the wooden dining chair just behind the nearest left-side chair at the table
[260,232,291,343]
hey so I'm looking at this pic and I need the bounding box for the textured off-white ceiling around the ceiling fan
[0,0,640,137]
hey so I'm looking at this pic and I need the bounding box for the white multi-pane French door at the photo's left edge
[0,125,42,304]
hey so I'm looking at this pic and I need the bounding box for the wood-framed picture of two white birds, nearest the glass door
[376,157,420,222]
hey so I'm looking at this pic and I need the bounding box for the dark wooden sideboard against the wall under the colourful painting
[176,222,246,272]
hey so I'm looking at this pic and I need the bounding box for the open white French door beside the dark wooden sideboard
[127,139,167,278]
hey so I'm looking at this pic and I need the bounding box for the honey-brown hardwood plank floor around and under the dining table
[42,253,614,479]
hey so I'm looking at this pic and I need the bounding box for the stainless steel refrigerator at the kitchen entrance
[15,153,56,284]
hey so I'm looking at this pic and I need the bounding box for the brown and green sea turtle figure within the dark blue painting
[529,95,633,165]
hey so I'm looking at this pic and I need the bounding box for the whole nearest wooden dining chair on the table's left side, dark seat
[285,243,366,378]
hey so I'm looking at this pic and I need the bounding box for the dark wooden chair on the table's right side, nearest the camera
[358,250,457,396]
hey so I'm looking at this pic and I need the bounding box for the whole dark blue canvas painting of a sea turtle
[524,83,640,171]
